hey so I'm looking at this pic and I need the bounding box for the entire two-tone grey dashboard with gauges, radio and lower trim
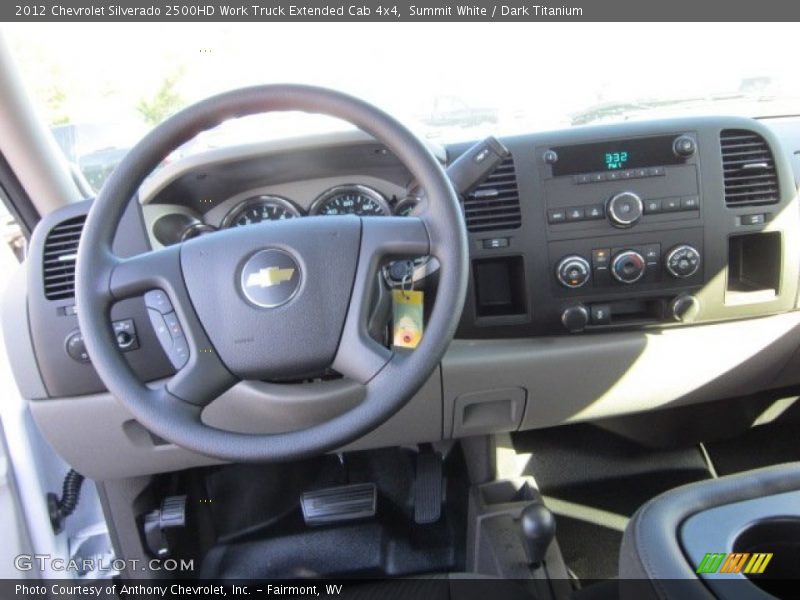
[5,111,800,475]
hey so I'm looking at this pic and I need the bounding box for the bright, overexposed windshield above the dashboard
[6,23,800,189]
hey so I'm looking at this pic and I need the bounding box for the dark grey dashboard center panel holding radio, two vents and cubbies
[455,118,800,338]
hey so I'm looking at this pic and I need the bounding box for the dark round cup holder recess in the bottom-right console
[733,517,800,598]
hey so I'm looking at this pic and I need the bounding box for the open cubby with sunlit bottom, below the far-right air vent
[725,232,781,304]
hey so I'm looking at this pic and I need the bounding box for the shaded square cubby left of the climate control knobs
[472,256,527,317]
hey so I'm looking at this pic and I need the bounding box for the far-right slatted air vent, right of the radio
[720,129,779,207]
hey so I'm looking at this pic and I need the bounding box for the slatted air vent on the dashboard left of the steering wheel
[44,215,86,300]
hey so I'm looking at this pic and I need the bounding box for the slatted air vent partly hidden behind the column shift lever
[464,156,522,232]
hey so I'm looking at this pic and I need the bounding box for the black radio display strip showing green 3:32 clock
[553,135,684,177]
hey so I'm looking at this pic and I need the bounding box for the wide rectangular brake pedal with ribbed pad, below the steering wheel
[300,483,378,525]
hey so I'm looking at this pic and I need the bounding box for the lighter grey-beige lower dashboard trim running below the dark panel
[29,312,800,480]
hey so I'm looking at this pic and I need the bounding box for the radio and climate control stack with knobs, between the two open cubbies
[536,131,705,332]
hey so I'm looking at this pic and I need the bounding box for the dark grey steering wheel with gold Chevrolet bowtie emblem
[76,85,469,461]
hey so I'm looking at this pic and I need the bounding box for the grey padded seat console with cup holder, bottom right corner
[620,463,800,600]
